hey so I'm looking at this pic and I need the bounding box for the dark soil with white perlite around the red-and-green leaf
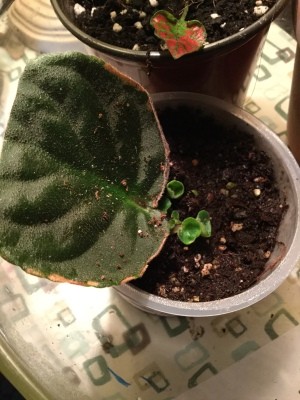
[71,0,276,51]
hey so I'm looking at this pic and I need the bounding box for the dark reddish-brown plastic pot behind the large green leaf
[51,0,288,105]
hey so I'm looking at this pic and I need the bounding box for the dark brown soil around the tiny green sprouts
[134,108,287,302]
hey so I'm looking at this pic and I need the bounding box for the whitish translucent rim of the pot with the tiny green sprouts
[114,92,300,317]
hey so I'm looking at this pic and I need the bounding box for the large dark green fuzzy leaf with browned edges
[0,53,168,287]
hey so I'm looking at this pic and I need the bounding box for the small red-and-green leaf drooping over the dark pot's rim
[151,6,206,59]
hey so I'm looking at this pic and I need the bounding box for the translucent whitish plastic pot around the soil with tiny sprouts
[116,92,300,317]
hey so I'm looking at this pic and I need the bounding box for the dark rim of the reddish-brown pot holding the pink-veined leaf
[50,0,289,63]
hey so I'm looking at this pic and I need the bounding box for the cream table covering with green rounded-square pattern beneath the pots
[0,16,300,400]
